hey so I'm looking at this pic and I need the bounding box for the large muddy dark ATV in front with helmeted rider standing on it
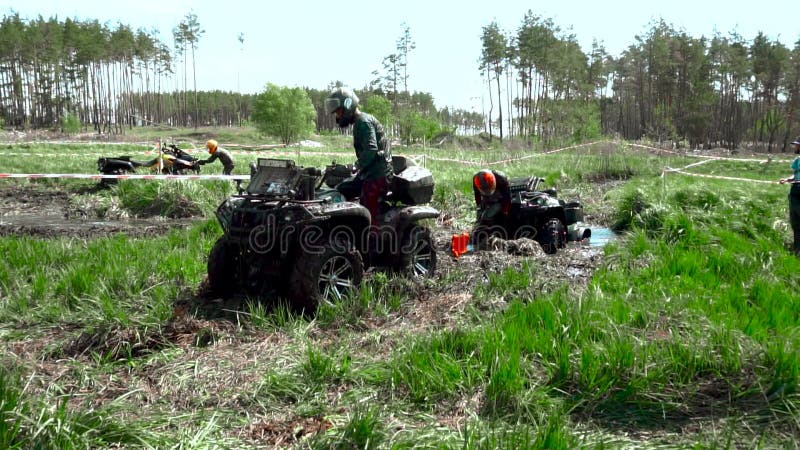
[208,156,439,311]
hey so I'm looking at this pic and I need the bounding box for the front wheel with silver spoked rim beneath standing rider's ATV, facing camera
[288,239,364,312]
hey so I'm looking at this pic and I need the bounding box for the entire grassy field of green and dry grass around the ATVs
[0,129,800,449]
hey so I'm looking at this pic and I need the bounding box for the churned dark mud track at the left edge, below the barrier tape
[0,184,198,239]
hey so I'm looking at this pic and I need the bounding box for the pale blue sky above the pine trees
[6,0,800,111]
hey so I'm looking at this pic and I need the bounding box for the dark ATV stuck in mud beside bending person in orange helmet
[470,177,591,254]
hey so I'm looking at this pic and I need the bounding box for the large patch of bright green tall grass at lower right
[348,174,800,442]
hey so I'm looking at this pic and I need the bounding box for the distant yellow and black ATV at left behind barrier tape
[97,144,200,186]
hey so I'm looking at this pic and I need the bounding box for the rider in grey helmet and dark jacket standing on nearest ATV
[325,87,392,242]
